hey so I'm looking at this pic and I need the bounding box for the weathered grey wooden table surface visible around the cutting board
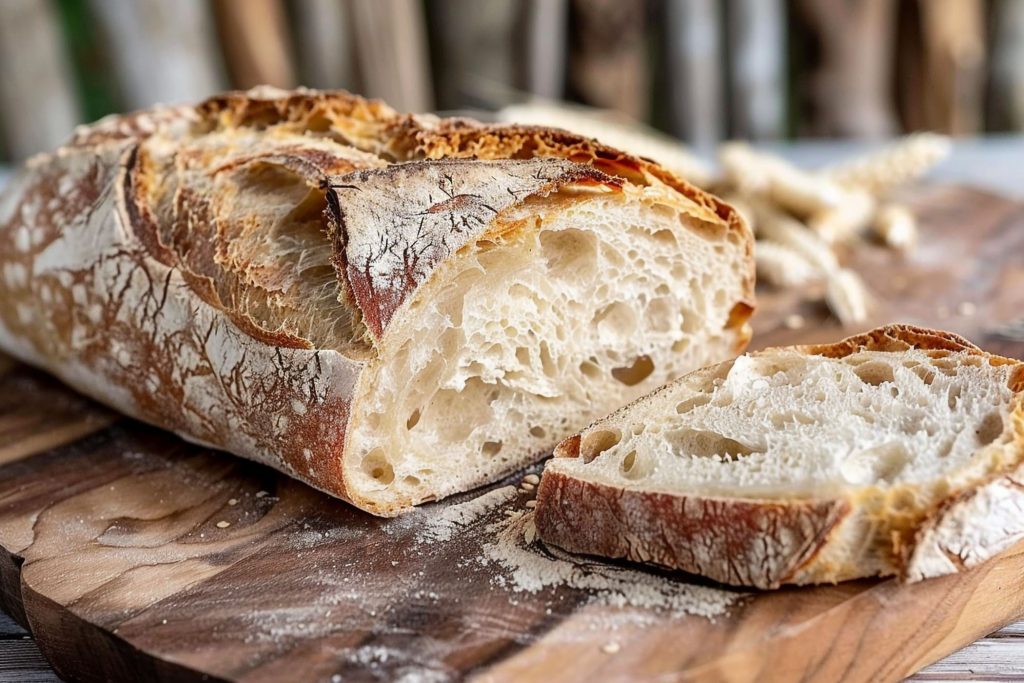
[0,136,1024,683]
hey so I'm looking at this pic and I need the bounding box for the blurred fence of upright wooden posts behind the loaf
[0,0,1024,159]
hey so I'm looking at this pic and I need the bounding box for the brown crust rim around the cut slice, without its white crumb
[536,325,1024,589]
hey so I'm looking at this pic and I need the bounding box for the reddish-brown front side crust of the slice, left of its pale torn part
[536,470,851,589]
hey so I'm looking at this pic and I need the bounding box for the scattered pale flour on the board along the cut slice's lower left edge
[478,511,743,618]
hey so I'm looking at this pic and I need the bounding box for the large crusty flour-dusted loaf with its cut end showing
[0,89,753,515]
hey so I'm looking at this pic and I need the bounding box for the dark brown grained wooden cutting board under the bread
[0,187,1024,682]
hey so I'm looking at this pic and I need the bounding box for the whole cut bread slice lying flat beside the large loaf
[537,326,1024,588]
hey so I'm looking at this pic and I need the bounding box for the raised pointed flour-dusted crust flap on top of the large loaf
[327,159,622,342]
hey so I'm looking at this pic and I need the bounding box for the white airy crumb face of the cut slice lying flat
[551,349,1015,505]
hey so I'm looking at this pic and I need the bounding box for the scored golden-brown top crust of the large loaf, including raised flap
[34,87,754,358]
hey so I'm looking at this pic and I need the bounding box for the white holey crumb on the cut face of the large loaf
[345,184,748,507]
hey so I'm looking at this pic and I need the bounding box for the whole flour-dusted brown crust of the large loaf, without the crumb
[0,88,754,514]
